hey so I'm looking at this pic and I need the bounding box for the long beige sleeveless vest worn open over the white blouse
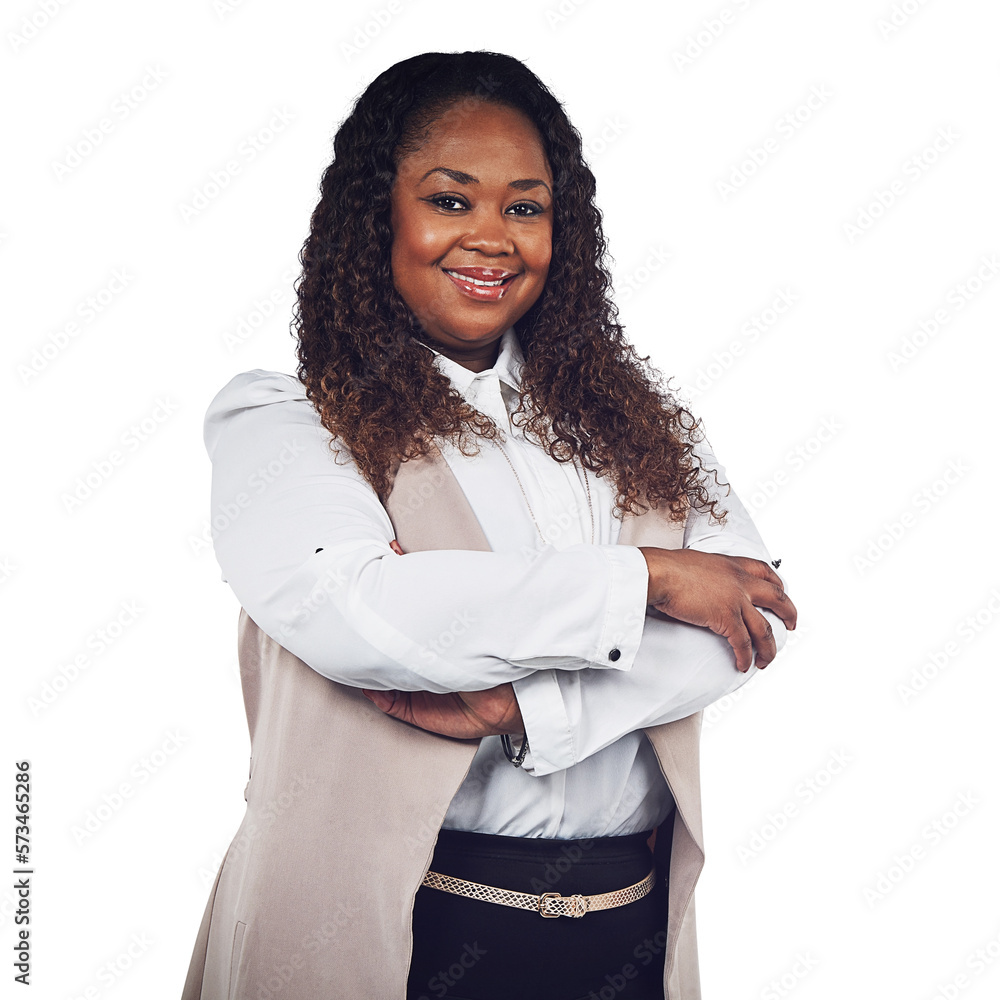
[182,449,705,1000]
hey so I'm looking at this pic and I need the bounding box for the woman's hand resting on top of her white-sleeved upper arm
[639,545,798,672]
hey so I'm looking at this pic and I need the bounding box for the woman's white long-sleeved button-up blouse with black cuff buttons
[205,327,787,839]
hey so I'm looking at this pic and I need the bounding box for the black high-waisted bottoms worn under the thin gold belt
[407,823,669,1000]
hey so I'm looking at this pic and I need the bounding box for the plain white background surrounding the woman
[0,0,1000,1000]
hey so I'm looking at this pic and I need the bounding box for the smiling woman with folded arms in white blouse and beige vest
[184,52,795,1000]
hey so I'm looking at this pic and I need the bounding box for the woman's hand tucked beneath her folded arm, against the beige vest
[361,684,524,740]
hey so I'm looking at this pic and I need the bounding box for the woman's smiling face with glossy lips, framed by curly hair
[392,98,552,371]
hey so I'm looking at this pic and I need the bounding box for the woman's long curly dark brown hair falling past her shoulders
[292,51,728,523]
